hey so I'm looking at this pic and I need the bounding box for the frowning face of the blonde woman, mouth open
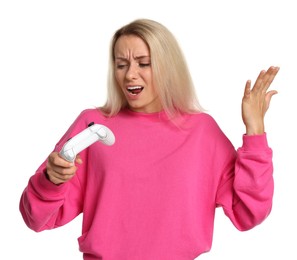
[114,35,162,113]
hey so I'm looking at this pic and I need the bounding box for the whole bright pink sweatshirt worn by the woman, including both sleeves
[20,109,274,260]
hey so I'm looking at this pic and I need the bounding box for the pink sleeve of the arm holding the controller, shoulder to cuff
[19,109,89,232]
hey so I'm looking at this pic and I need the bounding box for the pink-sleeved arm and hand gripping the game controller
[19,109,89,231]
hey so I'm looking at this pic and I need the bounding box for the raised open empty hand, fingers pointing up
[241,66,279,135]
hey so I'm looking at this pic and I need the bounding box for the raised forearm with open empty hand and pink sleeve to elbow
[217,67,279,230]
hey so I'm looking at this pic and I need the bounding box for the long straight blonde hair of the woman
[101,19,203,117]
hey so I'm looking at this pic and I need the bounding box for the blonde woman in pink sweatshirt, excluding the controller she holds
[20,19,279,260]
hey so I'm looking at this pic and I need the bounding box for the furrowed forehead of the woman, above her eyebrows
[114,35,150,57]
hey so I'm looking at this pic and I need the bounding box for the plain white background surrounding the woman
[0,0,297,260]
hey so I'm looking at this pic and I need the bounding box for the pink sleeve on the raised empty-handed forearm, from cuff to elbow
[217,134,274,230]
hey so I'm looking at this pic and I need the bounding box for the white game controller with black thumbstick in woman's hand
[60,122,115,162]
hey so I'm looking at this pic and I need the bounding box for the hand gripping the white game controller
[46,152,82,185]
